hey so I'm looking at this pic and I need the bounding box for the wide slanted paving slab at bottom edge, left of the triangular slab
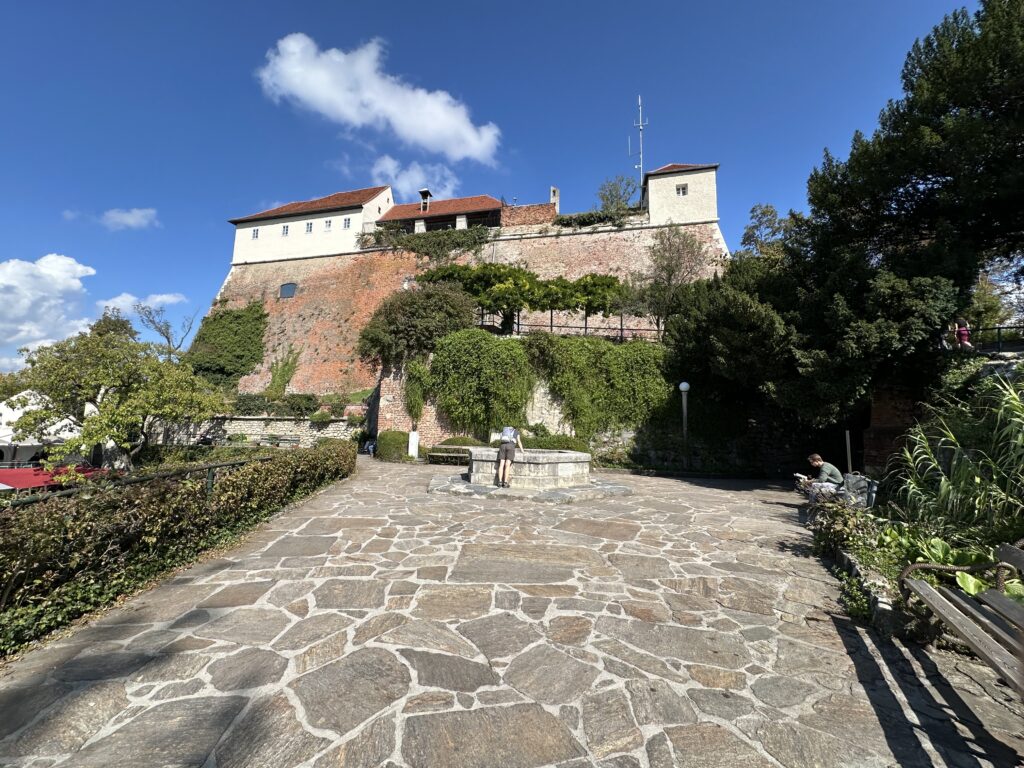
[65,696,246,768]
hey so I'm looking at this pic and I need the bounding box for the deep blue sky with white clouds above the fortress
[0,0,975,370]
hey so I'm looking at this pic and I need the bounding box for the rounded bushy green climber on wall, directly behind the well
[430,329,534,433]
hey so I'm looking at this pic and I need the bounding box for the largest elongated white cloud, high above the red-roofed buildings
[257,33,501,165]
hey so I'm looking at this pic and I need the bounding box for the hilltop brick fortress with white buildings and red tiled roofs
[213,163,728,394]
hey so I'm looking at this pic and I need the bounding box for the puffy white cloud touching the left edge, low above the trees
[0,253,96,370]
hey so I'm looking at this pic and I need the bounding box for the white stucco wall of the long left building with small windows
[231,187,394,264]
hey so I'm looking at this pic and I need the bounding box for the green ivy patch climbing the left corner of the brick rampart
[185,301,267,386]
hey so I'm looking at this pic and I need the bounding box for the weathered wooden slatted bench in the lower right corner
[899,540,1024,696]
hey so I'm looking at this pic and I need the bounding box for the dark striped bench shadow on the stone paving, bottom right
[831,615,1020,768]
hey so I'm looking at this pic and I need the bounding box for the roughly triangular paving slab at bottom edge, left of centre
[217,693,331,768]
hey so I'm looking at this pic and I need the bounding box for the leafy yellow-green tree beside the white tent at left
[15,327,223,467]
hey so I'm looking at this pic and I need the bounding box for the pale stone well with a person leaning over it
[468,447,590,490]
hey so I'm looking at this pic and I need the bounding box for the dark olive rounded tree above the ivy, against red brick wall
[356,283,475,370]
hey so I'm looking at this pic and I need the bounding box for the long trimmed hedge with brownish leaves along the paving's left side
[0,440,355,656]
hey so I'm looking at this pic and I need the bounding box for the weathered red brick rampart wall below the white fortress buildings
[218,218,718,393]
